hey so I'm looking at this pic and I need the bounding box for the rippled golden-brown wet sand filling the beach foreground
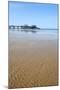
[9,35,58,88]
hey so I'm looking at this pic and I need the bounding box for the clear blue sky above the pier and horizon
[9,1,58,28]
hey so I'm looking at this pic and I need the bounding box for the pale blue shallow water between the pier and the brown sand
[9,29,58,40]
